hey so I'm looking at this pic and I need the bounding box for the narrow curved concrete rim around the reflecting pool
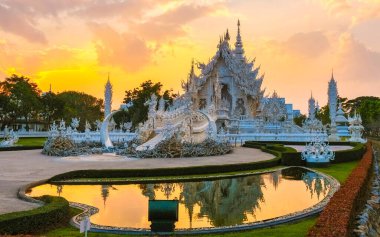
[18,166,340,235]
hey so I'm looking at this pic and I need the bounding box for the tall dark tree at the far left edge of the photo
[0,74,41,130]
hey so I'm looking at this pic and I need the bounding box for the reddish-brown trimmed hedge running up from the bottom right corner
[308,144,373,237]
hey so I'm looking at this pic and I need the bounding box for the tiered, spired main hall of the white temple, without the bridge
[182,21,298,132]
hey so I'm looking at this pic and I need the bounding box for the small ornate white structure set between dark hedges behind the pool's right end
[301,136,335,164]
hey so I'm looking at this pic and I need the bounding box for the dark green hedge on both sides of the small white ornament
[244,141,366,166]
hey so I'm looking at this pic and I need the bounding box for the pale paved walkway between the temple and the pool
[0,147,274,214]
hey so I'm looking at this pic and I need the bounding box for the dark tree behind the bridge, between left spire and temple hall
[114,80,176,128]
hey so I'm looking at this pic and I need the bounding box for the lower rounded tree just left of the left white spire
[57,91,103,131]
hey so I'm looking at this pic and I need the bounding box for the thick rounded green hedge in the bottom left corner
[0,195,70,235]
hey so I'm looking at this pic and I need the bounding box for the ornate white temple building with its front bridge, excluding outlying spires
[130,22,327,149]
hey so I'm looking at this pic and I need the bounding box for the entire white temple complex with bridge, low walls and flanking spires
[39,22,368,150]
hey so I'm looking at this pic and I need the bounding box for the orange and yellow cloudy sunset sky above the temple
[0,0,380,112]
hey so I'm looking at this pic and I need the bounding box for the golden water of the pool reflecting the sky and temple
[28,167,331,229]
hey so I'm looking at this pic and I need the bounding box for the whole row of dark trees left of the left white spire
[0,75,103,130]
